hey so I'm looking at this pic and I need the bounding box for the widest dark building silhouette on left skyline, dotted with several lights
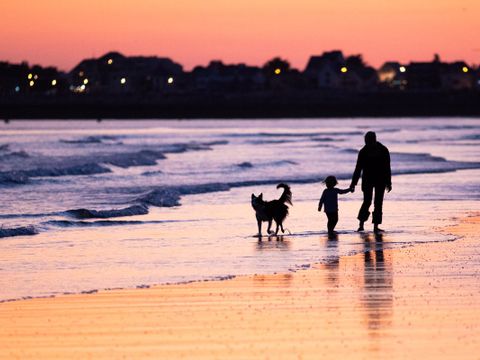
[70,52,183,94]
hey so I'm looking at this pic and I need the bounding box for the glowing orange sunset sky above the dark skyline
[0,0,480,70]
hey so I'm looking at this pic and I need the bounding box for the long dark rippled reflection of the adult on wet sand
[361,233,393,336]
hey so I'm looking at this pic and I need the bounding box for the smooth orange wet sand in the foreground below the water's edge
[0,216,480,359]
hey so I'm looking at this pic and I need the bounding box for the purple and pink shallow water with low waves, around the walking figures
[0,119,480,299]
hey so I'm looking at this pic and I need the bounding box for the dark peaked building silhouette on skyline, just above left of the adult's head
[304,51,378,91]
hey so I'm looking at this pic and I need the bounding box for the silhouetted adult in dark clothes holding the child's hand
[350,131,392,232]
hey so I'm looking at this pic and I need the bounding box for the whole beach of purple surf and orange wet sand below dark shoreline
[0,118,480,359]
